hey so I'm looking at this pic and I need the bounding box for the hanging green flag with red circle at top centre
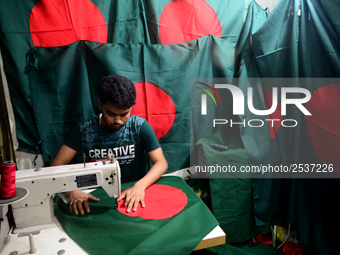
[145,0,247,45]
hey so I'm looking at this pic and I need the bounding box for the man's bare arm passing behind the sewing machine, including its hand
[51,144,99,215]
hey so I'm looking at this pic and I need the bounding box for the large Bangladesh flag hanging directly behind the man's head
[25,36,239,171]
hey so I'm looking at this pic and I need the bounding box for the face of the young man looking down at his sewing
[98,100,132,131]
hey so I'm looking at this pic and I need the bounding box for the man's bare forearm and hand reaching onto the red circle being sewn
[117,147,168,212]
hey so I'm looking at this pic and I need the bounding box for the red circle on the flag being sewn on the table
[118,184,188,220]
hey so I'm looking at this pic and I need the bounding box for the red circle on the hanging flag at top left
[29,0,107,47]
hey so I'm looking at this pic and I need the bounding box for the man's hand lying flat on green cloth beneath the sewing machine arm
[67,190,99,215]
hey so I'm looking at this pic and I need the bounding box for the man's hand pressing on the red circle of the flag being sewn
[117,183,145,212]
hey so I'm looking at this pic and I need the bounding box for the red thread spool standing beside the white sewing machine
[0,161,16,198]
